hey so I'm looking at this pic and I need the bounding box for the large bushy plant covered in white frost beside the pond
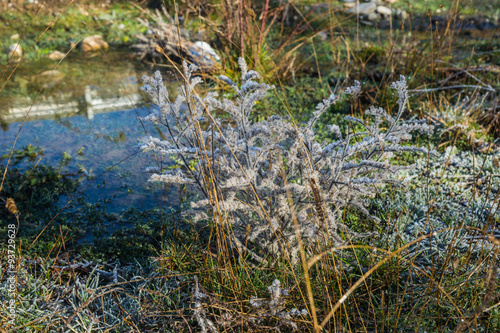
[140,58,432,261]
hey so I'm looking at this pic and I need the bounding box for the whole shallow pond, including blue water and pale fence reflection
[0,53,178,212]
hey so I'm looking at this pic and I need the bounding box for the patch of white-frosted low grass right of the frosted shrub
[376,147,500,267]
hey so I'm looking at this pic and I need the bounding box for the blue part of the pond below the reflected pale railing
[0,108,181,211]
